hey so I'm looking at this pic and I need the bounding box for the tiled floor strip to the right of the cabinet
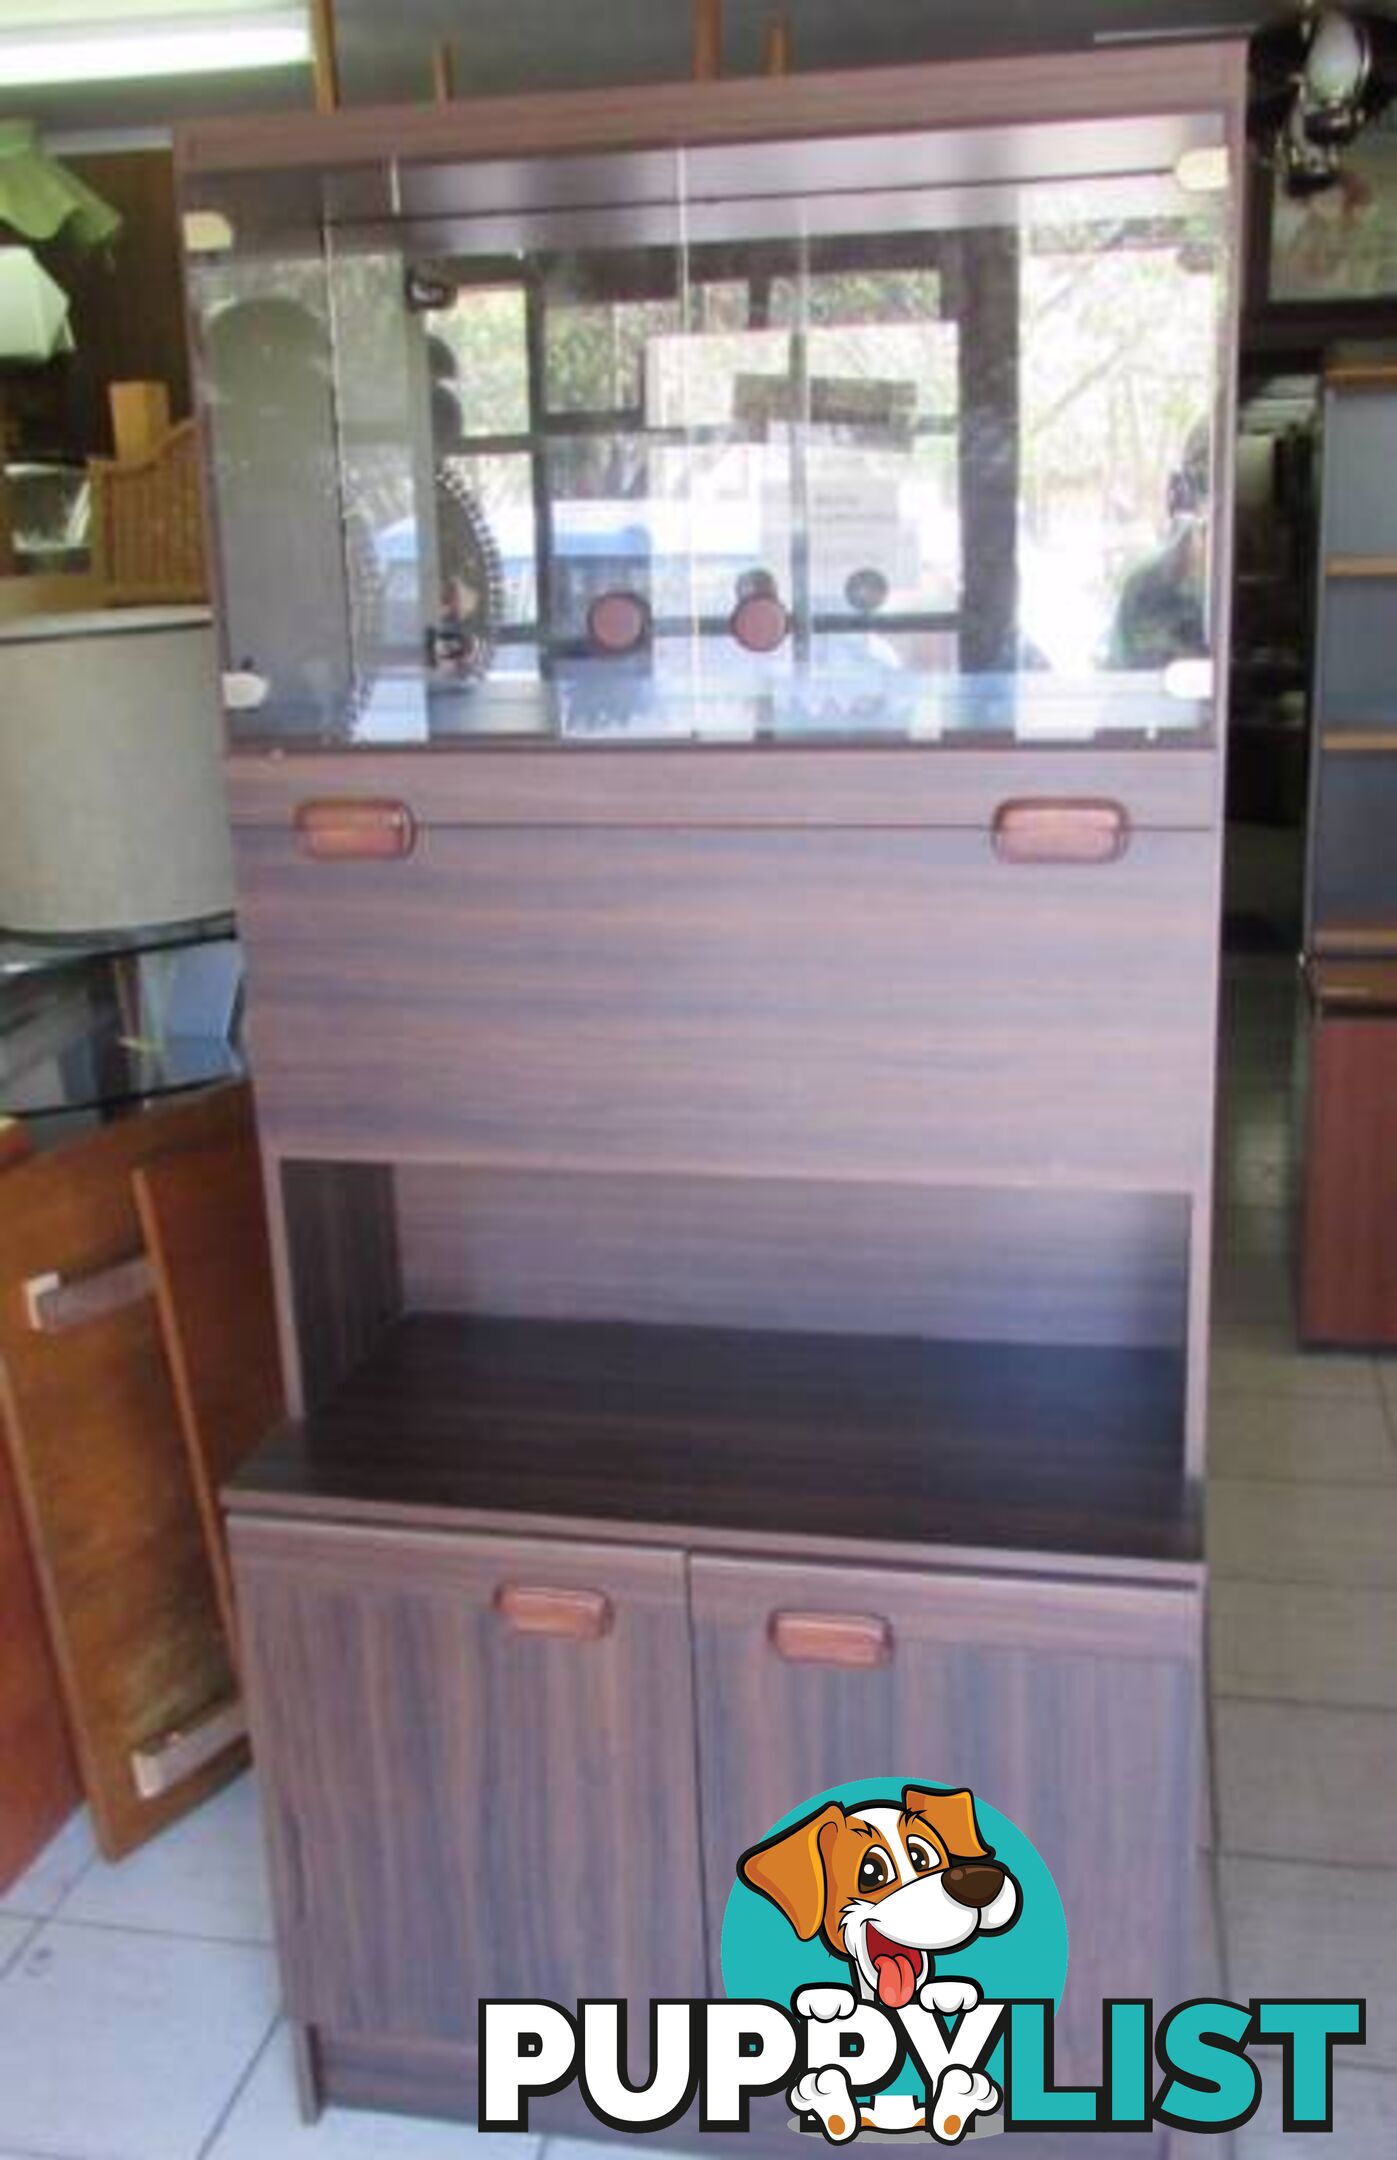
[1209,959,1397,2160]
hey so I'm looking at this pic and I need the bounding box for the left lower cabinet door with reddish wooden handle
[231,1518,704,2046]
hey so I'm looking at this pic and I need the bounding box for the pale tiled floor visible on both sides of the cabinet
[0,961,1397,2160]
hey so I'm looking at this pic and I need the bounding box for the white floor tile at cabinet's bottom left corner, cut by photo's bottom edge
[207,2026,537,2160]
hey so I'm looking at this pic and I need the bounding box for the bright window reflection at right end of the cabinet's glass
[1019,220,1218,672]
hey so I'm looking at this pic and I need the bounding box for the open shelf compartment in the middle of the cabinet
[238,1160,1201,1562]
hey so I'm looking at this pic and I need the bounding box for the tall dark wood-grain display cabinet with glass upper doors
[179,43,1246,2154]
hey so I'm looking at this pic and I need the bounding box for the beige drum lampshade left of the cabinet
[0,607,233,935]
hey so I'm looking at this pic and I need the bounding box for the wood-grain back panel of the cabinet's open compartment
[395,1164,1188,1348]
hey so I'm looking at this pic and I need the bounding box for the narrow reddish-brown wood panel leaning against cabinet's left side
[134,1130,285,1652]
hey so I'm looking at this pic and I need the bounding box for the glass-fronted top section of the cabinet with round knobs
[186,114,1233,747]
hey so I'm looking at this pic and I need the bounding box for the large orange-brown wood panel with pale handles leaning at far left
[0,1086,250,1858]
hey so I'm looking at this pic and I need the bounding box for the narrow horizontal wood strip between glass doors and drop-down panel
[225,743,1222,832]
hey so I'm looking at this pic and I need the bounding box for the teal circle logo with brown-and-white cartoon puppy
[721,1776,1067,2091]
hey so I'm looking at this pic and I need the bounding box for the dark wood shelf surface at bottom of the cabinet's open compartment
[235,1318,1201,1562]
